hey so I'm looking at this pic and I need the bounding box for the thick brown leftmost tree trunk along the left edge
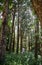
[0,0,8,64]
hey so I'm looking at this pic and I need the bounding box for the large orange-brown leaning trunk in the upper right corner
[32,0,42,55]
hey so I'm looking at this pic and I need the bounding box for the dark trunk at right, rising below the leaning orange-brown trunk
[35,21,40,59]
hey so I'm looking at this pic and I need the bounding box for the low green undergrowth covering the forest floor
[4,52,41,65]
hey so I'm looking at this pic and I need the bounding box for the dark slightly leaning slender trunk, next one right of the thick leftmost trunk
[10,5,16,51]
